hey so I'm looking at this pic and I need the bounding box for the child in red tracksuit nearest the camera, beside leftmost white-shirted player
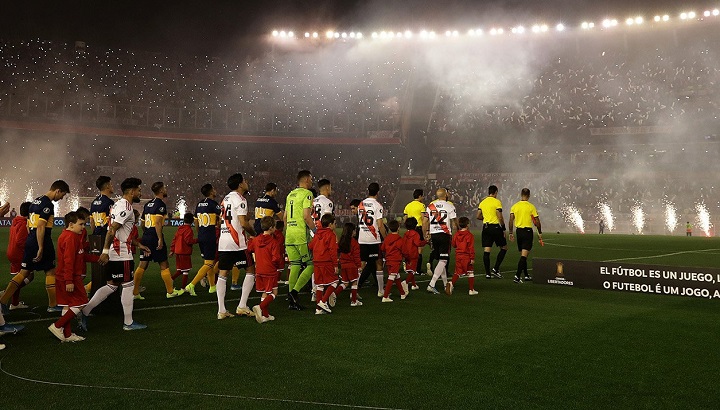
[48,212,88,342]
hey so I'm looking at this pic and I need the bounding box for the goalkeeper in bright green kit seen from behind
[283,170,315,310]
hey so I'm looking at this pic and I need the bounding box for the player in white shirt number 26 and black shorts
[358,182,387,297]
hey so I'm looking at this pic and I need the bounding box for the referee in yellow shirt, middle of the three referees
[477,185,507,279]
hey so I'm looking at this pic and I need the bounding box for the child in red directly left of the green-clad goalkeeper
[248,216,285,323]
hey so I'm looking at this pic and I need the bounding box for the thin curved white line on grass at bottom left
[0,356,401,410]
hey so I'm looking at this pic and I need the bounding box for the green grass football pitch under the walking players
[0,229,720,409]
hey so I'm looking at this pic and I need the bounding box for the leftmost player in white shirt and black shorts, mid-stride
[91,178,151,330]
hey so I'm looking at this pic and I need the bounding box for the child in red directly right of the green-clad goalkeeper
[308,214,338,315]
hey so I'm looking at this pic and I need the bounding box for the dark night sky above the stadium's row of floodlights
[0,0,720,54]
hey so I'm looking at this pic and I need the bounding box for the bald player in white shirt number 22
[423,188,458,295]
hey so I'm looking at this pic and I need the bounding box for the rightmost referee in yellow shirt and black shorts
[509,188,542,283]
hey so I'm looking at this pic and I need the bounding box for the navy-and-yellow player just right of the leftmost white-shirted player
[133,182,185,300]
